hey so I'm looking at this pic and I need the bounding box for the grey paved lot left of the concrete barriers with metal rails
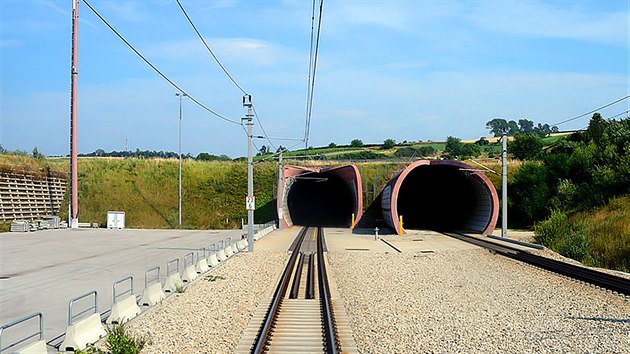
[0,229,243,342]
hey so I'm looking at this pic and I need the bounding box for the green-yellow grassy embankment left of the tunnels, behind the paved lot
[0,155,277,229]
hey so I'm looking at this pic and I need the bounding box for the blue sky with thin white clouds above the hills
[0,0,630,157]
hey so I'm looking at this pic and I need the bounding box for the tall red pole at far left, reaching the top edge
[69,0,79,229]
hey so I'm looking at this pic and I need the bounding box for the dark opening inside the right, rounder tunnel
[397,165,491,232]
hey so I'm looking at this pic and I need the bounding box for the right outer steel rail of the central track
[317,227,339,354]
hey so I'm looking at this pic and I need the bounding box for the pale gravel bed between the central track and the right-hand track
[328,250,630,353]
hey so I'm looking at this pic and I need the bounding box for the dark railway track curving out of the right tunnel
[444,232,630,296]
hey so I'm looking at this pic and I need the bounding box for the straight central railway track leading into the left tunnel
[239,228,354,354]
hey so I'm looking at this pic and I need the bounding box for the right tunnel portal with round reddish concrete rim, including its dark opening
[381,160,499,235]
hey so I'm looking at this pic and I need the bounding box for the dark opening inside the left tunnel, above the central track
[287,172,356,227]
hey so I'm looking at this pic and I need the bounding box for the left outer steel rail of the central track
[252,227,308,354]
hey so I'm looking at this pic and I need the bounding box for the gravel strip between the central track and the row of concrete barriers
[128,251,287,353]
